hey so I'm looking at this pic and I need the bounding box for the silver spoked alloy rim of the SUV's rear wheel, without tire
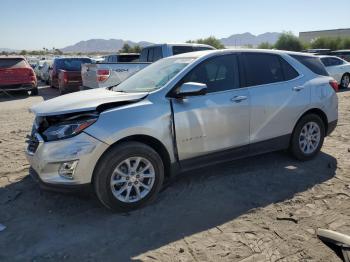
[299,122,321,154]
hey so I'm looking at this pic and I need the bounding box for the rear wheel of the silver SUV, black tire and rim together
[290,114,325,161]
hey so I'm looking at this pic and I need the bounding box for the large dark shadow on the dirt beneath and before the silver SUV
[0,152,337,261]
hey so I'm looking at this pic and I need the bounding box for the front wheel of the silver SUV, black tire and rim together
[93,142,164,212]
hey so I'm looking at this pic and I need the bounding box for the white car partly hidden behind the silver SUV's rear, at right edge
[320,55,350,88]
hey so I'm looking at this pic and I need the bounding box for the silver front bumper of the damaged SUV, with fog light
[26,133,108,186]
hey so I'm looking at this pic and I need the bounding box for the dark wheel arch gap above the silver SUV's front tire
[91,135,172,184]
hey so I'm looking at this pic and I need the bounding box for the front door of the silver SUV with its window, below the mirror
[173,54,250,161]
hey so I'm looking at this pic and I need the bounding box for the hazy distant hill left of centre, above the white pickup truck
[60,39,152,53]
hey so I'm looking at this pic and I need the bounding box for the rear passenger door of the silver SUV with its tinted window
[241,52,310,144]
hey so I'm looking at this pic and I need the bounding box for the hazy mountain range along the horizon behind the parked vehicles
[0,32,281,53]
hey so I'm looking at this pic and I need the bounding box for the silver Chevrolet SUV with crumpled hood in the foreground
[27,50,338,211]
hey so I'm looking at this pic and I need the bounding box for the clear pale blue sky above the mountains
[0,0,350,50]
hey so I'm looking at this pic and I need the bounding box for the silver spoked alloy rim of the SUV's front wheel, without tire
[110,157,155,203]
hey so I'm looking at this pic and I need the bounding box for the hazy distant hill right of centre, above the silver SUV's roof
[220,32,281,46]
